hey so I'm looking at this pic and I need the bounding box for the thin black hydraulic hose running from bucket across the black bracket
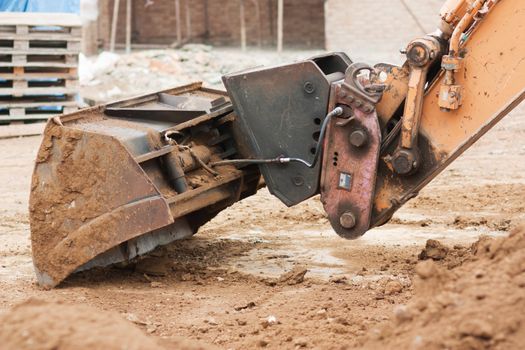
[210,107,343,168]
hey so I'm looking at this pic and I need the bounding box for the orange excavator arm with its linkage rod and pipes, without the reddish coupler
[371,0,525,226]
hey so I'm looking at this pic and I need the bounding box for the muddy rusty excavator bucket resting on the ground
[30,83,260,288]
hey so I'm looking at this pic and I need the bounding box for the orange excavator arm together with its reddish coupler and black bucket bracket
[224,0,525,238]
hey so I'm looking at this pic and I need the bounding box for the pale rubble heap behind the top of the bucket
[79,44,319,105]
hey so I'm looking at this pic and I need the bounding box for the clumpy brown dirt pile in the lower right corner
[365,227,525,349]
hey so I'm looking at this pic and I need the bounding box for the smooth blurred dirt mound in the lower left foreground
[0,299,213,350]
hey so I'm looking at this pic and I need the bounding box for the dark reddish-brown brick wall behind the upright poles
[98,0,325,48]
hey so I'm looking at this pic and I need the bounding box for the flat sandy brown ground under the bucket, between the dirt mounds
[0,48,525,349]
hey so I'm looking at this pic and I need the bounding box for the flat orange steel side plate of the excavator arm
[373,0,525,225]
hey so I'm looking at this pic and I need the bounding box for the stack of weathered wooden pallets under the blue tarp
[0,12,82,124]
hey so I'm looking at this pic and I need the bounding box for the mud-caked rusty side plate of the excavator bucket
[29,124,172,286]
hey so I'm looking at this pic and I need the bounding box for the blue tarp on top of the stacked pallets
[0,0,80,13]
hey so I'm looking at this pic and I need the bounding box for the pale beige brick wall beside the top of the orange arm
[325,0,444,63]
